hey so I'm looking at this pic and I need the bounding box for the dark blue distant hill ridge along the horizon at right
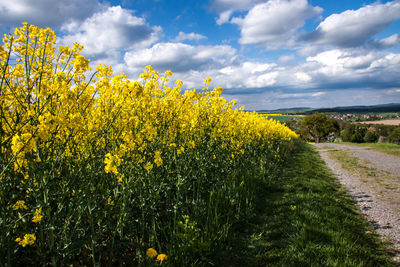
[257,103,400,114]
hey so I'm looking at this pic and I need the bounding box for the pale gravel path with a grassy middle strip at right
[315,143,400,262]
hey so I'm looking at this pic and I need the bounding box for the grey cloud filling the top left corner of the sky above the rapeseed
[0,0,100,27]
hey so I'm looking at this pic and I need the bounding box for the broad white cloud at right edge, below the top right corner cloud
[299,49,400,90]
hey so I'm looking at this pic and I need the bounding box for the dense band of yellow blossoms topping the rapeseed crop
[0,24,296,182]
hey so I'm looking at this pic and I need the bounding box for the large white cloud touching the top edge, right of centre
[231,0,322,49]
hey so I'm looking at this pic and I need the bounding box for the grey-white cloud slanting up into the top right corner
[302,0,400,48]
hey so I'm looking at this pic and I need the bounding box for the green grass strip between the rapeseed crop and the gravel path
[216,145,396,266]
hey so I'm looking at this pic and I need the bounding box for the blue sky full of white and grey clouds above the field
[0,0,400,110]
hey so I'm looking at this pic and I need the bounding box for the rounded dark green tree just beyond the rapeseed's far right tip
[300,113,338,143]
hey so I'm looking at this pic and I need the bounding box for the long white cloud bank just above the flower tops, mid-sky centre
[124,43,281,92]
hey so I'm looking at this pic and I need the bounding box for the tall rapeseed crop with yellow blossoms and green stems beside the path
[0,23,297,265]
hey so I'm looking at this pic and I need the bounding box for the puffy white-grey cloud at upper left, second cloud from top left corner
[60,6,162,64]
